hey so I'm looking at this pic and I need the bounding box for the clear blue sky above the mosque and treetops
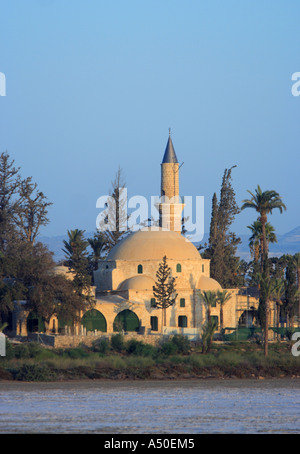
[0,0,300,239]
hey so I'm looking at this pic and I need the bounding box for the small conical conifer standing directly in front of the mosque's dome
[153,256,177,330]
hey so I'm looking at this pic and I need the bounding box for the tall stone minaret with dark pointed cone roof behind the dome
[159,129,184,233]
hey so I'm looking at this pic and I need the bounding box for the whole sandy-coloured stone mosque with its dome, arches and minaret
[12,135,274,339]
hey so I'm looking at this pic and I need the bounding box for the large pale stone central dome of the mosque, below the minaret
[107,228,201,261]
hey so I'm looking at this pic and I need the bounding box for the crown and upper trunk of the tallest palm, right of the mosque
[241,185,286,271]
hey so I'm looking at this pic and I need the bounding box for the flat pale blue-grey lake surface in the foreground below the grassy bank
[0,379,300,434]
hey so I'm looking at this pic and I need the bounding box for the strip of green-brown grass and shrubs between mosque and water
[0,335,300,381]
